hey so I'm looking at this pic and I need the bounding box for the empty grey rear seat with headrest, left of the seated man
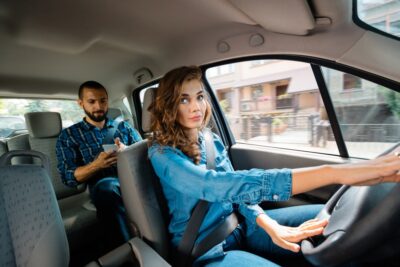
[24,112,98,249]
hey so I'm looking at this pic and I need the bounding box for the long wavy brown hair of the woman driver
[148,66,211,164]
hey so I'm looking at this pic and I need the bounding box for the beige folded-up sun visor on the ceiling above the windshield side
[229,0,315,35]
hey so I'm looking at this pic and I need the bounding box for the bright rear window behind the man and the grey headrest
[0,98,84,137]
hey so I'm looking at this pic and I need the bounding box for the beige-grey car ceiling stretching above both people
[0,0,400,100]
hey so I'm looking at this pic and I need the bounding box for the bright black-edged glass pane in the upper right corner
[356,0,400,38]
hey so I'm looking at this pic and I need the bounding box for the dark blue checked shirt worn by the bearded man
[56,119,142,187]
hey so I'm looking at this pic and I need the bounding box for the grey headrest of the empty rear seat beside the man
[25,112,62,138]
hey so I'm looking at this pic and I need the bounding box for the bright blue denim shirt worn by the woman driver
[149,133,292,246]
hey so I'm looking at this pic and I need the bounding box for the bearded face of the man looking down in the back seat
[78,88,108,122]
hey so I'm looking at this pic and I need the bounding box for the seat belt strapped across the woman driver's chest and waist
[177,128,215,267]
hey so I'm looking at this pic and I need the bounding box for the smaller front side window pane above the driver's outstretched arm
[322,68,400,158]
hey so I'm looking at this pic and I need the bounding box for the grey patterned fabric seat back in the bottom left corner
[0,153,69,267]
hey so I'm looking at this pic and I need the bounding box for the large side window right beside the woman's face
[206,60,339,154]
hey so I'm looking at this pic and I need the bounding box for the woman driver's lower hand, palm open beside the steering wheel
[256,214,328,252]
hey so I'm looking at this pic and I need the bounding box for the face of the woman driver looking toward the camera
[178,79,206,130]
